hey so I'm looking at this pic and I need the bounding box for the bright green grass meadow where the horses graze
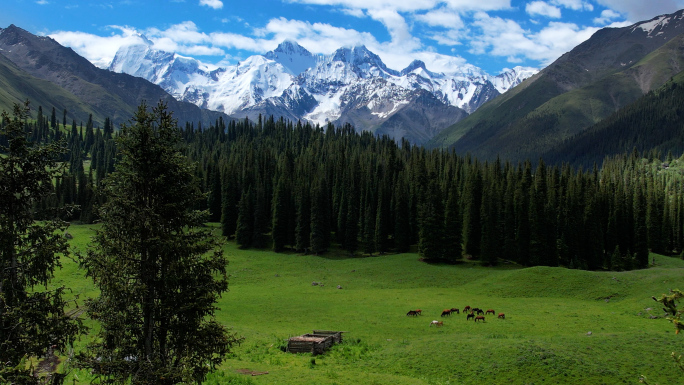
[56,226,684,385]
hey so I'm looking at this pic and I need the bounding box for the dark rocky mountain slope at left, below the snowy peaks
[0,25,230,124]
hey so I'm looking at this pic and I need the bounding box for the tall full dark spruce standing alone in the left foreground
[78,102,239,384]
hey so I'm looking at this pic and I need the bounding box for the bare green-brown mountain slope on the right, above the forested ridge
[429,11,684,160]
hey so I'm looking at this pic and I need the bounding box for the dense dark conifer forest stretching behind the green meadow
[8,100,684,270]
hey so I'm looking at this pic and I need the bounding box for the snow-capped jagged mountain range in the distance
[109,41,536,143]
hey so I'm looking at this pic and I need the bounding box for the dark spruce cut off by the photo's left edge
[0,102,84,384]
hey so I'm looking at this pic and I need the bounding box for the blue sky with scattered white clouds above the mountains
[0,0,684,75]
